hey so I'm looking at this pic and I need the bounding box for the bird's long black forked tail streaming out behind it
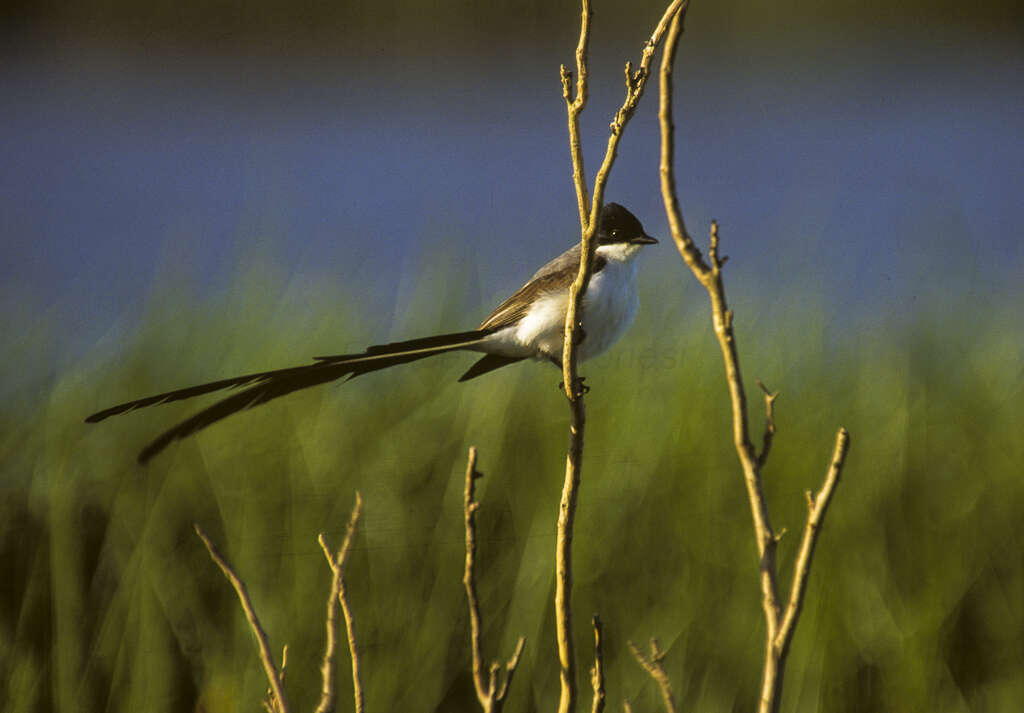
[85,330,520,463]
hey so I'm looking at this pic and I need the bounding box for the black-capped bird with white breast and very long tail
[85,203,657,464]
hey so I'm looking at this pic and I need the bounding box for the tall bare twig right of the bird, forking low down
[658,6,849,713]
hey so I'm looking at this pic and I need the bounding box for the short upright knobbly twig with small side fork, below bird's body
[462,446,526,713]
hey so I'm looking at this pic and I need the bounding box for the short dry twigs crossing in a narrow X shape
[316,492,364,713]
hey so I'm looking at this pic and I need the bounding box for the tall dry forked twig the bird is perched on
[555,5,689,713]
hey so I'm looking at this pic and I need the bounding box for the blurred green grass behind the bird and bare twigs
[0,246,1024,713]
